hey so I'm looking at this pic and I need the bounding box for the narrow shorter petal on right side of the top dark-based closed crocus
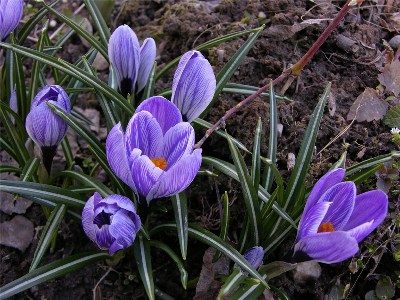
[137,38,157,92]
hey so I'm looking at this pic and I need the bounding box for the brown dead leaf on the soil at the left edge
[0,215,33,252]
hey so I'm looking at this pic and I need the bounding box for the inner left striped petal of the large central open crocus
[125,111,163,158]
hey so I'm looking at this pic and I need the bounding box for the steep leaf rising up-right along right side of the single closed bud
[200,25,264,117]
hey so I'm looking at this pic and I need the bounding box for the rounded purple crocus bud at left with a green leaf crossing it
[25,85,71,147]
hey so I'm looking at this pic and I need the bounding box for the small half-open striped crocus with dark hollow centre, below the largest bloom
[82,192,141,255]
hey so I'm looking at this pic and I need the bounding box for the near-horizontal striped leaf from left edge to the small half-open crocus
[0,180,85,209]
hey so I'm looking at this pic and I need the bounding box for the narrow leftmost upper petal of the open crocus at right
[303,169,346,215]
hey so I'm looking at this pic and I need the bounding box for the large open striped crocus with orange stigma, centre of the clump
[106,96,201,203]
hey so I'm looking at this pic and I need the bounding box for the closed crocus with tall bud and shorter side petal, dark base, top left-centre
[108,25,156,97]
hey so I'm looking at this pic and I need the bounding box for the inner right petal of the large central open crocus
[162,122,194,171]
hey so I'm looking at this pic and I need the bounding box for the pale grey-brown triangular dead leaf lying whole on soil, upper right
[347,88,388,122]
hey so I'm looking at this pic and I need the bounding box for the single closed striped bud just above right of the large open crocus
[171,50,216,122]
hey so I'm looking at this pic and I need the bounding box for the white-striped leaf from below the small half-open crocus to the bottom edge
[133,235,155,300]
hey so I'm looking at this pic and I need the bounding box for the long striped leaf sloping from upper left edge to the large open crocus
[0,42,134,115]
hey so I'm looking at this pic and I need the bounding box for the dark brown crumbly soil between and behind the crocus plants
[0,0,400,299]
